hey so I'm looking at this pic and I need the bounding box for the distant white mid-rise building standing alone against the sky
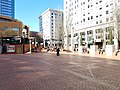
[39,9,64,47]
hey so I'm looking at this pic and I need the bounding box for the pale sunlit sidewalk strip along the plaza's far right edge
[49,52,120,60]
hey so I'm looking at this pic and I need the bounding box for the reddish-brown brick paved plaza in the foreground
[0,53,120,90]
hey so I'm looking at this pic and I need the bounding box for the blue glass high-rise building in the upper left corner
[0,0,15,18]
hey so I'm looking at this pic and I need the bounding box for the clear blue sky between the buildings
[15,0,63,31]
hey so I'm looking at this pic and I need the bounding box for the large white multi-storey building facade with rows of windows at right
[64,0,120,51]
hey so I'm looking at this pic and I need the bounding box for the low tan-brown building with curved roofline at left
[0,16,30,37]
